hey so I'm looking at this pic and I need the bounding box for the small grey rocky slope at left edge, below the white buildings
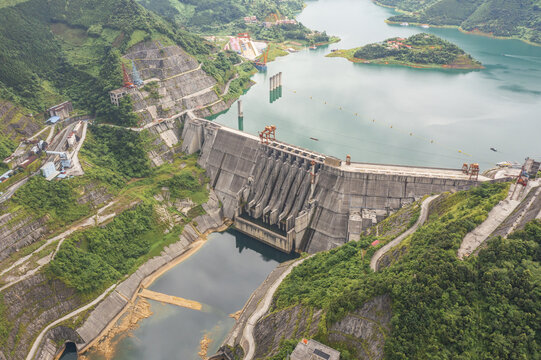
[0,213,49,261]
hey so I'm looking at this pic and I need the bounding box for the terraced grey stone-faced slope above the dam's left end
[125,41,223,124]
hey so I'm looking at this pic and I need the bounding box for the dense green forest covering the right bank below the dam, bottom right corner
[275,184,541,359]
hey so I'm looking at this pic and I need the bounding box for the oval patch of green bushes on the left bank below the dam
[49,204,157,293]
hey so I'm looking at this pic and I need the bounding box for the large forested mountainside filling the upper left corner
[0,0,211,124]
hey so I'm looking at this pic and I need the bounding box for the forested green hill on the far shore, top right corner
[378,0,541,43]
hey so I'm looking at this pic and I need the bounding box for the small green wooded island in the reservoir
[327,33,484,70]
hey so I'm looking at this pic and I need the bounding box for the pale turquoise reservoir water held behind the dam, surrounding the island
[215,0,541,169]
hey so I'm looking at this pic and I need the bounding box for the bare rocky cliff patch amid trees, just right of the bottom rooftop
[329,295,391,360]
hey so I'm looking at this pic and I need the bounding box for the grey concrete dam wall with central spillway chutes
[182,114,489,253]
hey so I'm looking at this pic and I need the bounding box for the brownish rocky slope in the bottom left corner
[0,274,83,360]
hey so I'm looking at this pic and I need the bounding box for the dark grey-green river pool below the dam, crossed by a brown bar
[88,230,292,360]
